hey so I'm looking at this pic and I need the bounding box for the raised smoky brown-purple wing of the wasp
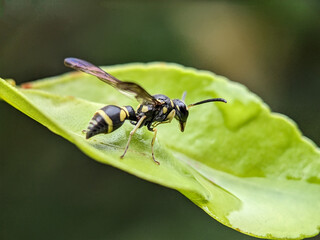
[64,58,160,105]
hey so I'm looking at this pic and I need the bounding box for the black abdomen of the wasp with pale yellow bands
[86,105,136,139]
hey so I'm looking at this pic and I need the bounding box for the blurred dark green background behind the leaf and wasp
[0,0,320,240]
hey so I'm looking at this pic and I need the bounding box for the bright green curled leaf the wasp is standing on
[0,63,320,239]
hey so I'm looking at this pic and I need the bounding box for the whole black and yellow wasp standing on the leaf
[64,58,227,164]
